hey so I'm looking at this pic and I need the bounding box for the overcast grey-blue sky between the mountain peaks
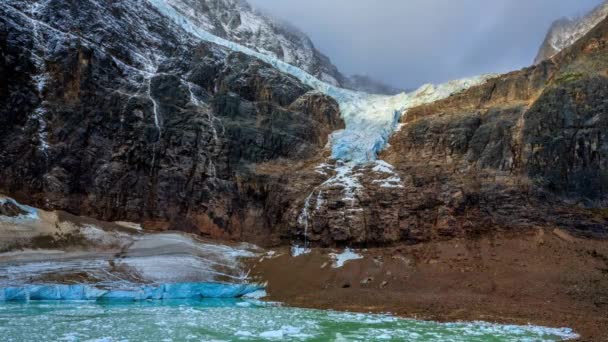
[249,0,601,88]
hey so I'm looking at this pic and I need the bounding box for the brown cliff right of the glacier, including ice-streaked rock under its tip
[280,16,608,245]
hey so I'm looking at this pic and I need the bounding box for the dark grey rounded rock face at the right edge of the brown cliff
[522,77,608,200]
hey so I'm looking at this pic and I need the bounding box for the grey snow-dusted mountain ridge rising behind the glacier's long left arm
[167,0,400,94]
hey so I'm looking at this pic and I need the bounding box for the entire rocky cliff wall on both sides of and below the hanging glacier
[0,0,608,246]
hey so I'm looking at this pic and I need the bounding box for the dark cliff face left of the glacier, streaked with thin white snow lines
[0,1,343,246]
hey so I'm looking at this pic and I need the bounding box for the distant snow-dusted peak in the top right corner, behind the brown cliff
[534,1,608,64]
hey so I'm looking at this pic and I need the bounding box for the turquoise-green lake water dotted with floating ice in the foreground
[0,299,575,342]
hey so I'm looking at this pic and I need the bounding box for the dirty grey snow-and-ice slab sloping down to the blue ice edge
[0,197,260,288]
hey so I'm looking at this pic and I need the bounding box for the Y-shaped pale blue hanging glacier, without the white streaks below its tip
[148,0,495,164]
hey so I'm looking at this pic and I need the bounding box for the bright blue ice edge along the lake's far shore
[0,283,264,302]
